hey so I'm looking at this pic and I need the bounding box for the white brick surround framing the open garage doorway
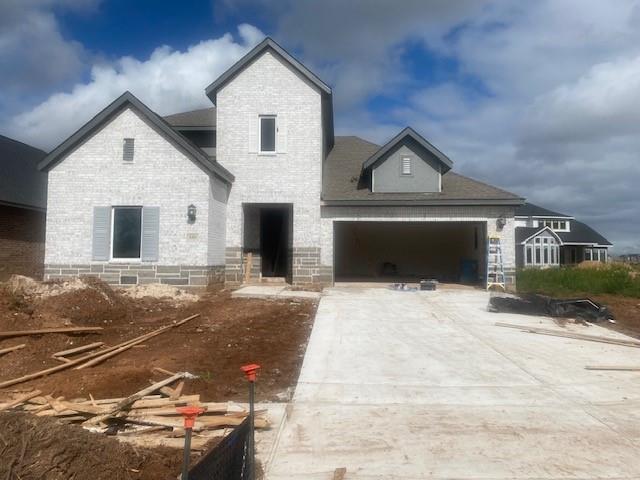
[320,206,516,270]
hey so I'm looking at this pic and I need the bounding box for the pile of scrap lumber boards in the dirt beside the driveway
[0,369,269,450]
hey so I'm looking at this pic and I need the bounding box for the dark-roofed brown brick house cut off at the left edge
[0,135,47,281]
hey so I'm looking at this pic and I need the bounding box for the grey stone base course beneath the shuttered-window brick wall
[44,263,225,287]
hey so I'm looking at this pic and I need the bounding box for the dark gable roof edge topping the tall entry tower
[205,37,331,104]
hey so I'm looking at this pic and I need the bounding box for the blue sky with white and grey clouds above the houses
[0,0,640,252]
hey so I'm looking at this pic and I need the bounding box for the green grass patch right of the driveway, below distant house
[516,264,640,298]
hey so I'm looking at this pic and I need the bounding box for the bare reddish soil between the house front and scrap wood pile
[0,280,316,401]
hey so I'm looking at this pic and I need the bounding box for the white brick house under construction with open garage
[41,39,524,285]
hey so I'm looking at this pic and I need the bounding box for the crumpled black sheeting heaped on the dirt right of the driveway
[488,294,614,322]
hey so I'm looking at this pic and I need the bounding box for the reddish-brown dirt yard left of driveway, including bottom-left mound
[0,280,317,480]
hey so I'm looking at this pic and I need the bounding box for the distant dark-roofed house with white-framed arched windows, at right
[516,203,612,267]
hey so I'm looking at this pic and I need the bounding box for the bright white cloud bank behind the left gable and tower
[5,24,264,149]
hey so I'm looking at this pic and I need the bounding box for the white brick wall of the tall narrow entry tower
[216,52,322,247]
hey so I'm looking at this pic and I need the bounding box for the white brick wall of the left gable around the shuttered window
[45,105,224,265]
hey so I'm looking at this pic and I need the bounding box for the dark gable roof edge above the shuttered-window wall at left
[38,91,235,183]
